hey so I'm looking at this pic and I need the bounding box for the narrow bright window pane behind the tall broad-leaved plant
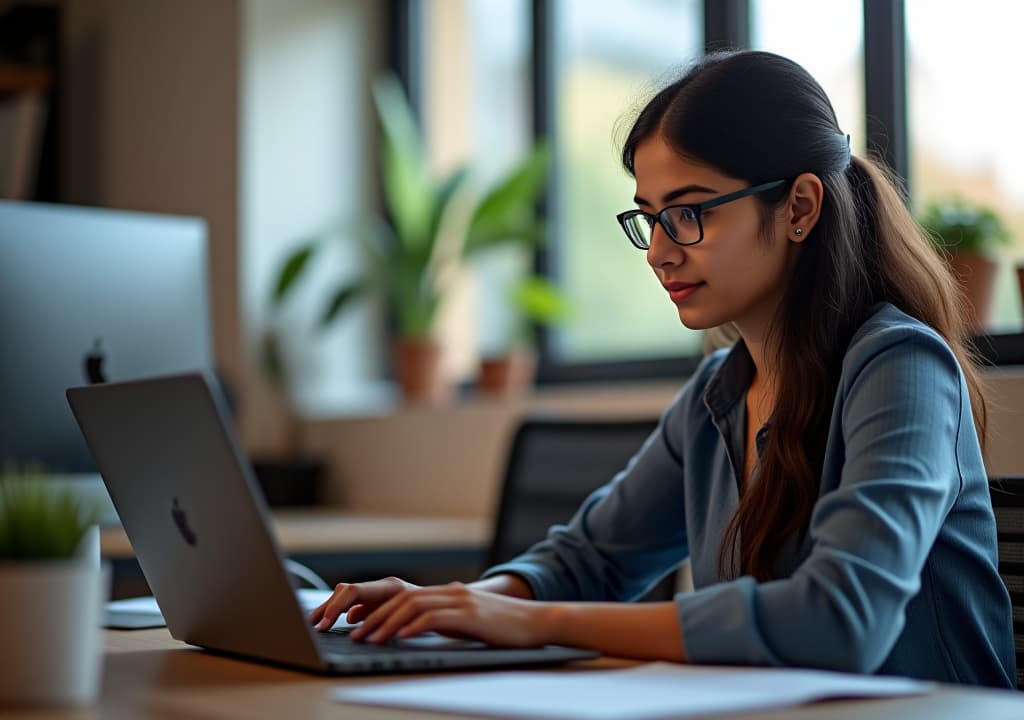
[420,0,532,379]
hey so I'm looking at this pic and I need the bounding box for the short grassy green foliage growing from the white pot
[0,464,100,560]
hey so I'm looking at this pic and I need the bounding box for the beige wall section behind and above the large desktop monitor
[62,0,243,389]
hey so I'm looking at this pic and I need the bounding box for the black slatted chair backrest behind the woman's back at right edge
[988,476,1024,690]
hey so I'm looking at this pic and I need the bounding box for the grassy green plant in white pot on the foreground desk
[0,465,109,706]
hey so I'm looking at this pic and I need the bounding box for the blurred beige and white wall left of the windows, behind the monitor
[61,0,383,454]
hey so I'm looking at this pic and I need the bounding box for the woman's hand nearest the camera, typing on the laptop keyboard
[351,583,561,647]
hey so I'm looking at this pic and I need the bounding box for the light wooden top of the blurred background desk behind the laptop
[99,509,490,558]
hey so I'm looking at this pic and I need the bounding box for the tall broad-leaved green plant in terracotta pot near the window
[271,76,548,403]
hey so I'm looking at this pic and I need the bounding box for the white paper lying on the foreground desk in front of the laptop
[333,663,934,720]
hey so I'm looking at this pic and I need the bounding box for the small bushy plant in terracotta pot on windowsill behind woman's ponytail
[920,199,1010,333]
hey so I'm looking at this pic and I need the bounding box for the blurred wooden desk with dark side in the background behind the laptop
[99,508,490,599]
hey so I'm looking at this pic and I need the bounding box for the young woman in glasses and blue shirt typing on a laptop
[310,52,1015,687]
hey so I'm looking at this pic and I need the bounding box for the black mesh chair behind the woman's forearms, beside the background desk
[486,418,676,601]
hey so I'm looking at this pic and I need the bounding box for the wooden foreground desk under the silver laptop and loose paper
[8,630,1024,720]
